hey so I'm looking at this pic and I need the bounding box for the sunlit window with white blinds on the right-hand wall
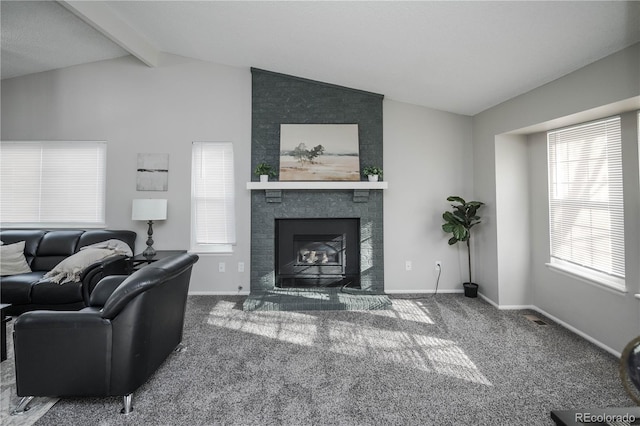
[547,117,625,289]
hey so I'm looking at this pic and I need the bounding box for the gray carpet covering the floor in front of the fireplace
[31,294,632,425]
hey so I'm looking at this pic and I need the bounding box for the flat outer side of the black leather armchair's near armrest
[13,310,112,396]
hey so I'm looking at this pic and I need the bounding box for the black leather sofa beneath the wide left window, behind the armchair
[0,229,136,316]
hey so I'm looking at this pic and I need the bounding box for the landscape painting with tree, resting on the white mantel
[279,124,360,181]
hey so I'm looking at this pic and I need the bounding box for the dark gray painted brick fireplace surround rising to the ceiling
[245,69,386,310]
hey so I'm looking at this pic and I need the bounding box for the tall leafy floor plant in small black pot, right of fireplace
[442,195,484,297]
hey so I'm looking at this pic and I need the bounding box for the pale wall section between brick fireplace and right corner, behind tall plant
[383,100,473,293]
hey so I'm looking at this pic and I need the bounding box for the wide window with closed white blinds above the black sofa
[0,141,107,228]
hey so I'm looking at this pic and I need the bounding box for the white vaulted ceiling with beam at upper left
[0,1,640,115]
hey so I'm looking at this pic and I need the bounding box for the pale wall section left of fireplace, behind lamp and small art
[2,55,251,293]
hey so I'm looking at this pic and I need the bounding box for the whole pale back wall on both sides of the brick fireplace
[2,55,472,293]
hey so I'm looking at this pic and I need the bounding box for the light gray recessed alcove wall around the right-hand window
[528,112,640,352]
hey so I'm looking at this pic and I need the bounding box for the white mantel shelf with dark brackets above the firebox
[247,181,389,203]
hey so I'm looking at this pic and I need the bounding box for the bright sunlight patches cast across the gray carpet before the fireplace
[207,302,492,386]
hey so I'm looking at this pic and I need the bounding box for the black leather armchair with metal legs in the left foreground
[13,253,198,414]
